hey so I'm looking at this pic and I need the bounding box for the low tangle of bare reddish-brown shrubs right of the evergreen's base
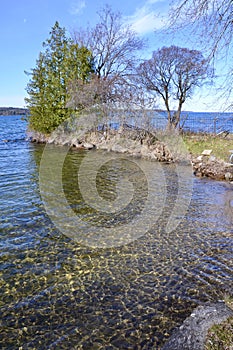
[68,75,155,130]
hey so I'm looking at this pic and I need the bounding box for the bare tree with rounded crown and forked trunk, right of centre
[138,46,209,127]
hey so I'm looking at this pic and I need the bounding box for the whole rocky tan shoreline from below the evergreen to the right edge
[28,124,233,184]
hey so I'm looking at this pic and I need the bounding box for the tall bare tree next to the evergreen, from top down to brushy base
[70,5,145,125]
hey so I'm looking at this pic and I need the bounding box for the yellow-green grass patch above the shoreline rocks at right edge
[184,134,233,162]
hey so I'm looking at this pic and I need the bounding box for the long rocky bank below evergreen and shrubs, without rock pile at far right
[29,125,177,163]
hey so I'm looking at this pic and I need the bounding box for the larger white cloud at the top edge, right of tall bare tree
[126,0,166,34]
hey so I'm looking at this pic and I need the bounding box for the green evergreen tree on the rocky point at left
[25,22,93,134]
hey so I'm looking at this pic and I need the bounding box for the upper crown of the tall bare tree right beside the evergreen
[74,5,144,78]
